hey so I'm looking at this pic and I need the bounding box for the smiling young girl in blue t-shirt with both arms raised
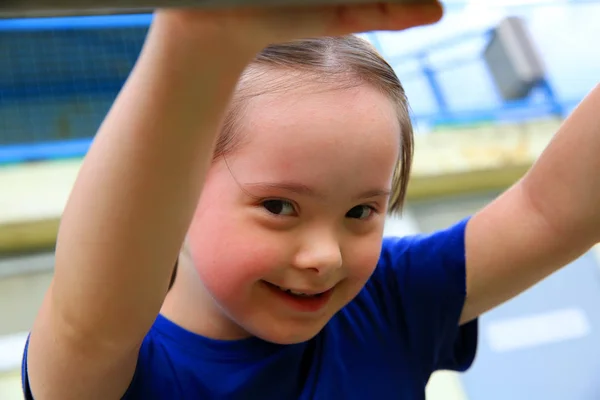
[23,6,600,400]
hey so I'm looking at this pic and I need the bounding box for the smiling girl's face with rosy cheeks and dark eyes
[188,85,400,343]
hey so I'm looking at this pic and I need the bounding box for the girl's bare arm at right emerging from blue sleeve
[462,86,600,322]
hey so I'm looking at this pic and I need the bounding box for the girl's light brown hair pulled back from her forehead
[214,35,414,213]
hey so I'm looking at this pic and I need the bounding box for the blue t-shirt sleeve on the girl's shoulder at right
[376,219,477,379]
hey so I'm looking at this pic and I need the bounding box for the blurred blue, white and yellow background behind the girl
[0,0,600,400]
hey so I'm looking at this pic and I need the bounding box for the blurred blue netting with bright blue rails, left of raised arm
[0,16,150,162]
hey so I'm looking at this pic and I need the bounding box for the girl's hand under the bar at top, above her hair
[158,1,443,51]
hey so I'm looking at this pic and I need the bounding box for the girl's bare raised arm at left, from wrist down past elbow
[27,14,259,399]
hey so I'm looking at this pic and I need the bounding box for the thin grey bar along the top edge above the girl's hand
[0,0,434,17]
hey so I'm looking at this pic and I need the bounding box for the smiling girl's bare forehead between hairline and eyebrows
[225,86,400,188]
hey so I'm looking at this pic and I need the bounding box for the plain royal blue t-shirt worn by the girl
[23,220,477,400]
